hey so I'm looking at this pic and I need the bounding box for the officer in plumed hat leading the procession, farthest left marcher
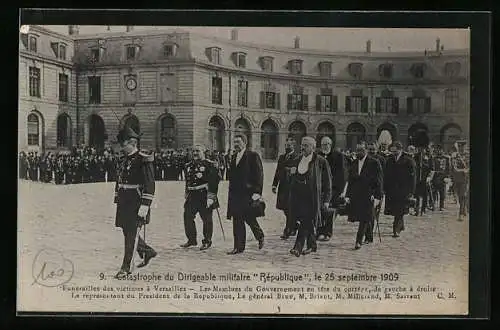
[115,127,156,279]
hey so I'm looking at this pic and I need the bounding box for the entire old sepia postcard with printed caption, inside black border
[17,20,471,315]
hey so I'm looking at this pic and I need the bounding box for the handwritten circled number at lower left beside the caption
[32,249,75,287]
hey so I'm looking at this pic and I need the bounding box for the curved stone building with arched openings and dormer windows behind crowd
[16,29,470,159]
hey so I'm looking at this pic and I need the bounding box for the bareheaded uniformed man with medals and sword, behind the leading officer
[181,145,219,250]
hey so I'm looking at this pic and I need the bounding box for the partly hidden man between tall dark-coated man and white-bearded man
[272,137,299,239]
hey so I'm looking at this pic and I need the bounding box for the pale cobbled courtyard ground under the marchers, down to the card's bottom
[18,164,469,314]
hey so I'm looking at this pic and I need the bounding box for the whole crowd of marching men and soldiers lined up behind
[19,127,469,278]
